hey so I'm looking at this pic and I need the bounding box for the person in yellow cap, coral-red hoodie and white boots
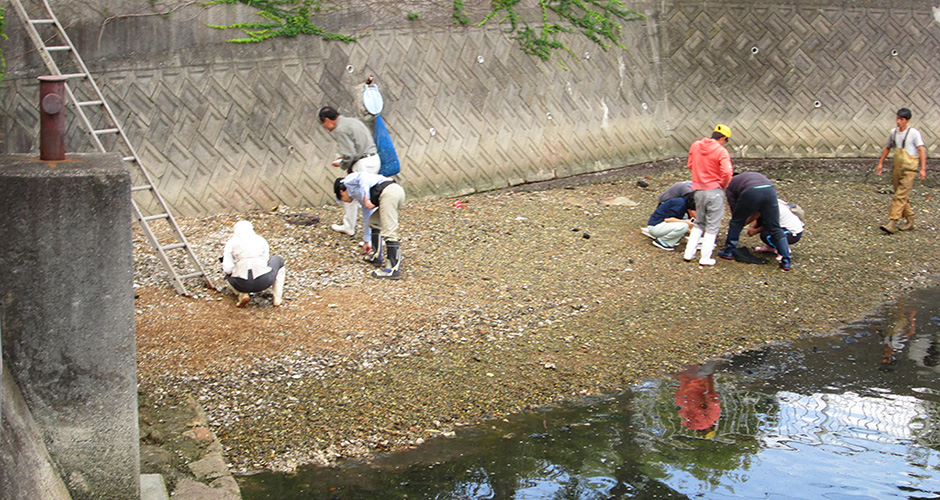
[683,125,734,266]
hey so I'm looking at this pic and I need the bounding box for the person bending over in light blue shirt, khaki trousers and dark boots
[333,172,405,280]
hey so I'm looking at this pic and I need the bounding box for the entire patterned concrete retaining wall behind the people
[0,0,940,215]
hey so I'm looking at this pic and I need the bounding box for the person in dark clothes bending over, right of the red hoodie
[718,172,791,271]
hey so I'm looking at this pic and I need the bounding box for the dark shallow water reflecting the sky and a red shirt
[239,289,940,500]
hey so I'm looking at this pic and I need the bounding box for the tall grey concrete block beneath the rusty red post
[0,154,140,500]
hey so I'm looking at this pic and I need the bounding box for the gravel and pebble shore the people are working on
[134,159,940,472]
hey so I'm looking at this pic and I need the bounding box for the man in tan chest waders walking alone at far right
[875,108,927,234]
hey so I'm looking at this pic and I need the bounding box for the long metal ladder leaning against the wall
[10,0,215,295]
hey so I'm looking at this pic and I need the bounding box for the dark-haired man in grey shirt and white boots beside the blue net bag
[319,106,382,241]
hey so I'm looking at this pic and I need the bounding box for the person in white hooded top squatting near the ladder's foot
[222,220,287,307]
